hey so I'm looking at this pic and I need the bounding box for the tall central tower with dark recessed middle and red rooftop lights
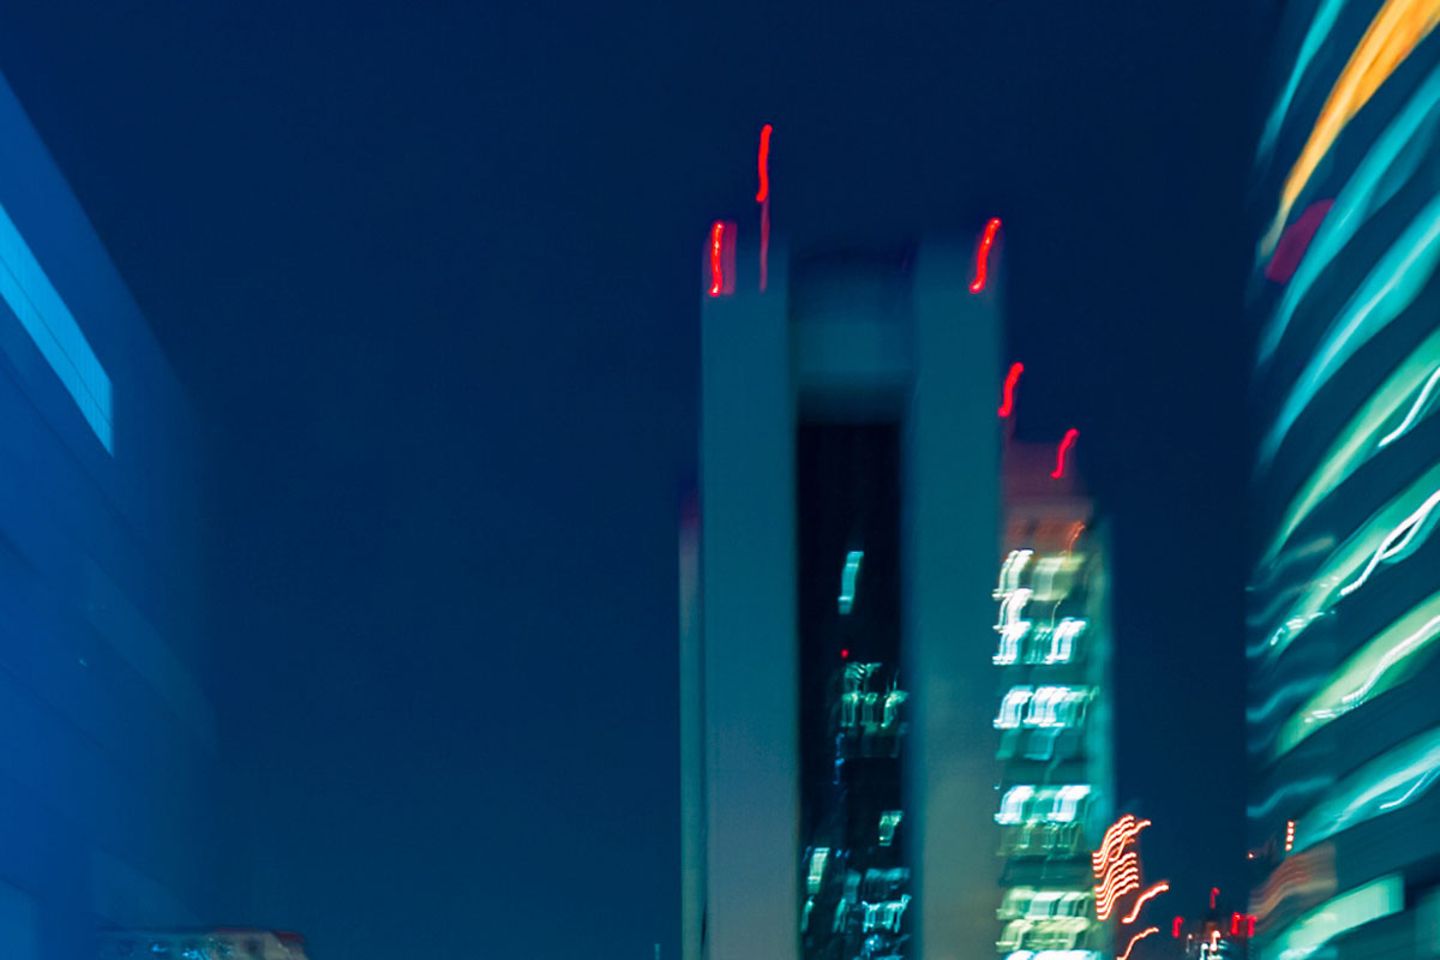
[681,223,1001,960]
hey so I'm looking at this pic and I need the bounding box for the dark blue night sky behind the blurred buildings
[0,0,1257,960]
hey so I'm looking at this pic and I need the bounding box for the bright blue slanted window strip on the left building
[0,200,114,453]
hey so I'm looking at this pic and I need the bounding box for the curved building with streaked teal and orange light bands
[1247,0,1440,960]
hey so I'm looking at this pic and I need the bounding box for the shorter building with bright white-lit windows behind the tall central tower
[991,443,1117,960]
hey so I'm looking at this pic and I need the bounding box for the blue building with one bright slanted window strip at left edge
[0,67,219,960]
